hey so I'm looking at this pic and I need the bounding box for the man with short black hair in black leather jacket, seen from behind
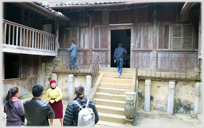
[23,84,55,126]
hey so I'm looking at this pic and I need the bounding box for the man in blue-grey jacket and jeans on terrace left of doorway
[67,40,78,70]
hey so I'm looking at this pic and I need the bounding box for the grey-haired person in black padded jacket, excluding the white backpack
[63,83,99,126]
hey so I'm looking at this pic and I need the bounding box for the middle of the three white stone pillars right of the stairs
[167,81,175,115]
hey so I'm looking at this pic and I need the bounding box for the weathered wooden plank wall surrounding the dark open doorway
[59,3,198,67]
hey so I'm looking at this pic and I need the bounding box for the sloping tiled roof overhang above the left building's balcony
[18,2,70,21]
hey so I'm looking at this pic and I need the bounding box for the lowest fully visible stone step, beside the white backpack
[98,113,125,124]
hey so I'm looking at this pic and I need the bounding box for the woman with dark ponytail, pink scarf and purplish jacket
[4,87,25,126]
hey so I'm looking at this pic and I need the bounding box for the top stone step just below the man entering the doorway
[103,72,133,79]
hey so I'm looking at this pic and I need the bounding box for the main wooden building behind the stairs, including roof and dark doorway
[44,2,201,69]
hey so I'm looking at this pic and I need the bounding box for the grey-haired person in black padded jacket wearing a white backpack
[63,83,99,126]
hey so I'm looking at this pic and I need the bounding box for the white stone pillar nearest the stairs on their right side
[144,79,151,112]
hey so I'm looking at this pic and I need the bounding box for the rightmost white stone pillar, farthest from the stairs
[194,82,202,114]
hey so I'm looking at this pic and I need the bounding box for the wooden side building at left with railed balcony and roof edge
[2,2,70,97]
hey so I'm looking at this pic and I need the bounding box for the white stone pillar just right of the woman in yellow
[68,74,74,102]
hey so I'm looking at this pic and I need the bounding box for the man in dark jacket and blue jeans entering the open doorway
[114,43,127,75]
